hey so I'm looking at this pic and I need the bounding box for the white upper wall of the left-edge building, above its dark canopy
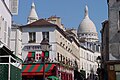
[0,0,11,47]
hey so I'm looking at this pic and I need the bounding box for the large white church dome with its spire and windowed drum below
[77,6,98,42]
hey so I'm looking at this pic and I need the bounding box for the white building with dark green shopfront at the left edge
[0,0,21,80]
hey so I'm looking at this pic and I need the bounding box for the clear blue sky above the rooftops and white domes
[13,0,108,40]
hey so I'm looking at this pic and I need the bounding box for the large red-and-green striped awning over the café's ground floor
[22,64,55,75]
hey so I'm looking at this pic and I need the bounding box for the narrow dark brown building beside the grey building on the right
[100,20,109,80]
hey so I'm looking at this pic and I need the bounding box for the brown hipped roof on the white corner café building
[20,19,57,27]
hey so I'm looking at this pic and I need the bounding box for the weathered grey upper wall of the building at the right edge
[108,0,120,60]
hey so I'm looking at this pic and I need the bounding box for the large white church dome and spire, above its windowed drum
[78,6,97,33]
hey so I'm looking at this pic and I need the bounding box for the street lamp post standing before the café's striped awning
[40,38,51,80]
